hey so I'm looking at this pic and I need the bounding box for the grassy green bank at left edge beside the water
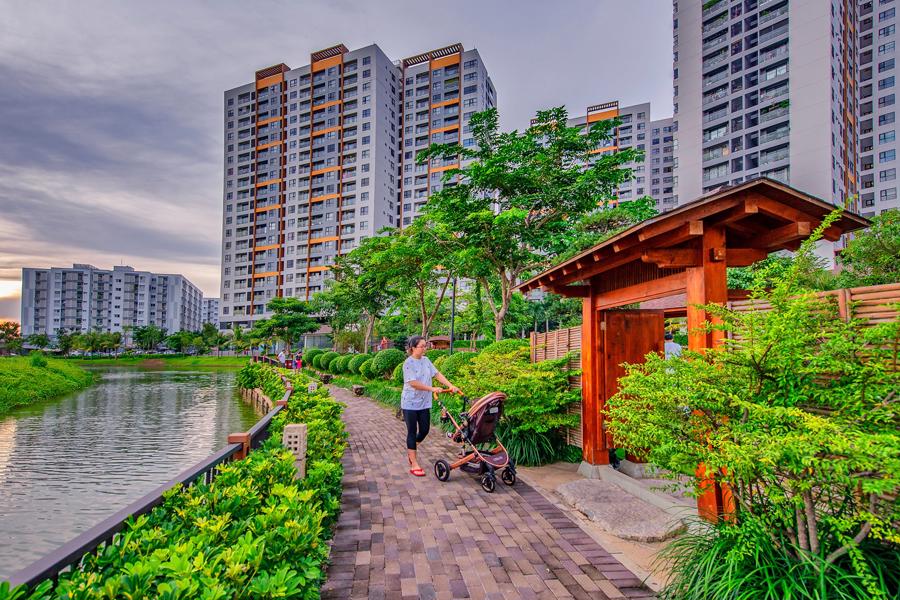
[0,356,94,415]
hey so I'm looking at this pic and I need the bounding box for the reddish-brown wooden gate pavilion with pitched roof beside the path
[519,178,868,515]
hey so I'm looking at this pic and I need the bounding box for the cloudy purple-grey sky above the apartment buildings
[0,0,672,320]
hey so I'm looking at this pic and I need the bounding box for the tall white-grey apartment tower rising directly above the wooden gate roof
[673,0,859,230]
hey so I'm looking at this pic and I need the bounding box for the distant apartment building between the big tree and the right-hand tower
[567,101,678,212]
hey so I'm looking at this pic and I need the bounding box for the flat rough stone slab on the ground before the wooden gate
[556,479,685,542]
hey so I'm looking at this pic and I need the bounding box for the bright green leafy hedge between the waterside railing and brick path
[16,363,346,600]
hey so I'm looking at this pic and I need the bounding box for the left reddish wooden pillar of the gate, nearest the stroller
[581,293,609,465]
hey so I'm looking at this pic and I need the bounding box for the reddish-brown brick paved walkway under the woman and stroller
[322,387,653,600]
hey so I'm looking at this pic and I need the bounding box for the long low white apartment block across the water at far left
[22,264,203,337]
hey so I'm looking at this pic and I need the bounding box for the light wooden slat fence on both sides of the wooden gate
[531,283,900,448]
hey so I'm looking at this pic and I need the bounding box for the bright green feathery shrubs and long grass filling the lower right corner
[607,220,900,599]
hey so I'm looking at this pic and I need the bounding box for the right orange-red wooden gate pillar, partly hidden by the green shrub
[687,226,731,520]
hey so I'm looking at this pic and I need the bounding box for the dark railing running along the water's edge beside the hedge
[9,356,294,588]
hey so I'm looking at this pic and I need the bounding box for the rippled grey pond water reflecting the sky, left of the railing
[0,368,258,581]
